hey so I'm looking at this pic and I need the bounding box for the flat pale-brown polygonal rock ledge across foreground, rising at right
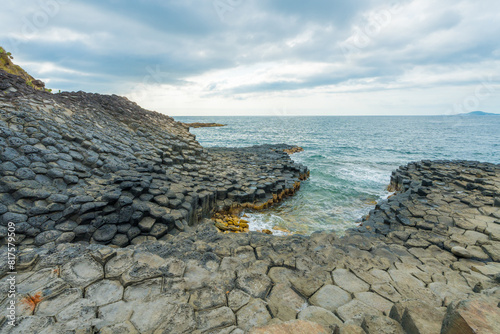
[0,161,500,334]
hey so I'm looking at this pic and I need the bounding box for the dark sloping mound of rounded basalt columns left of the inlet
[0,72,307,247]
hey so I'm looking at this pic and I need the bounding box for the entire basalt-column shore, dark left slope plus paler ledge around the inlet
[0,71,500,334]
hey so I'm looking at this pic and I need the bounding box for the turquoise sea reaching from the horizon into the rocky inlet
[174,116,500,234]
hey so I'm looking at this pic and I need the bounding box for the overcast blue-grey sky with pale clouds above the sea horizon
[0,0,500,115]
